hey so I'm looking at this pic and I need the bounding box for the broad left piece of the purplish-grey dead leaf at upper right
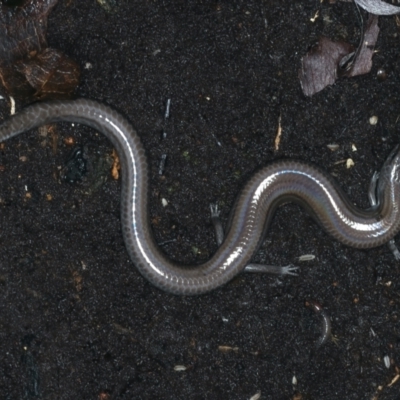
[299,36,353,96]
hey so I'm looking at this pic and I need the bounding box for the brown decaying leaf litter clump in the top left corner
[0,0,80,101]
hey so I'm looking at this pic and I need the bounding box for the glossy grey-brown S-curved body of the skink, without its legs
[0,99,400,295]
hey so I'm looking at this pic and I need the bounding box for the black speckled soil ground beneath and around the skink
[0,0,400,400]
